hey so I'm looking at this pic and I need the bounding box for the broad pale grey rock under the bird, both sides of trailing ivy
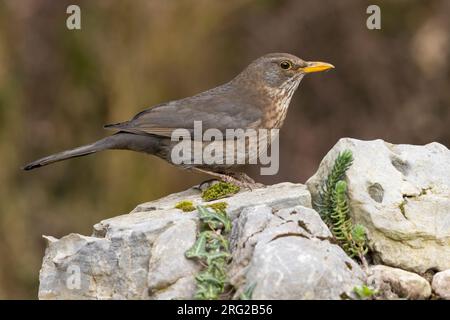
[39,183,364,299]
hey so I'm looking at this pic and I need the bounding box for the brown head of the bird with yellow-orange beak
[239,53,334,90]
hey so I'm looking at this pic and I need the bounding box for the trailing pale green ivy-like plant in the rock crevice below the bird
[185,206,231,300]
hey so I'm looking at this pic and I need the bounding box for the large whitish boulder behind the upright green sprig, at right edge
[307,138,450,273]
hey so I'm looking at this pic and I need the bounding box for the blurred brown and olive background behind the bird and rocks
[0,0,450,299]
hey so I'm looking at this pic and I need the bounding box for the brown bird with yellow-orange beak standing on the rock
[24,53,334,184]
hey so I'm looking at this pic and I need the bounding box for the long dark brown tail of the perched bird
[23,132,158,170]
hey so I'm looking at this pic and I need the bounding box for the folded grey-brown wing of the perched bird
[105,89,262,137]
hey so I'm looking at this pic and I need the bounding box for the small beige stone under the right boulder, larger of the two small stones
[368,265,431,299]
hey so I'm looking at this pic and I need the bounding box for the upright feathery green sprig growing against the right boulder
[316,150,368,264]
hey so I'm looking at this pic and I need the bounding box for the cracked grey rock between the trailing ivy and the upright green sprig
[230,206,365,299]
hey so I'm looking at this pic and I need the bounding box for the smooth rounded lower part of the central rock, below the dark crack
[247,235,363,300]
